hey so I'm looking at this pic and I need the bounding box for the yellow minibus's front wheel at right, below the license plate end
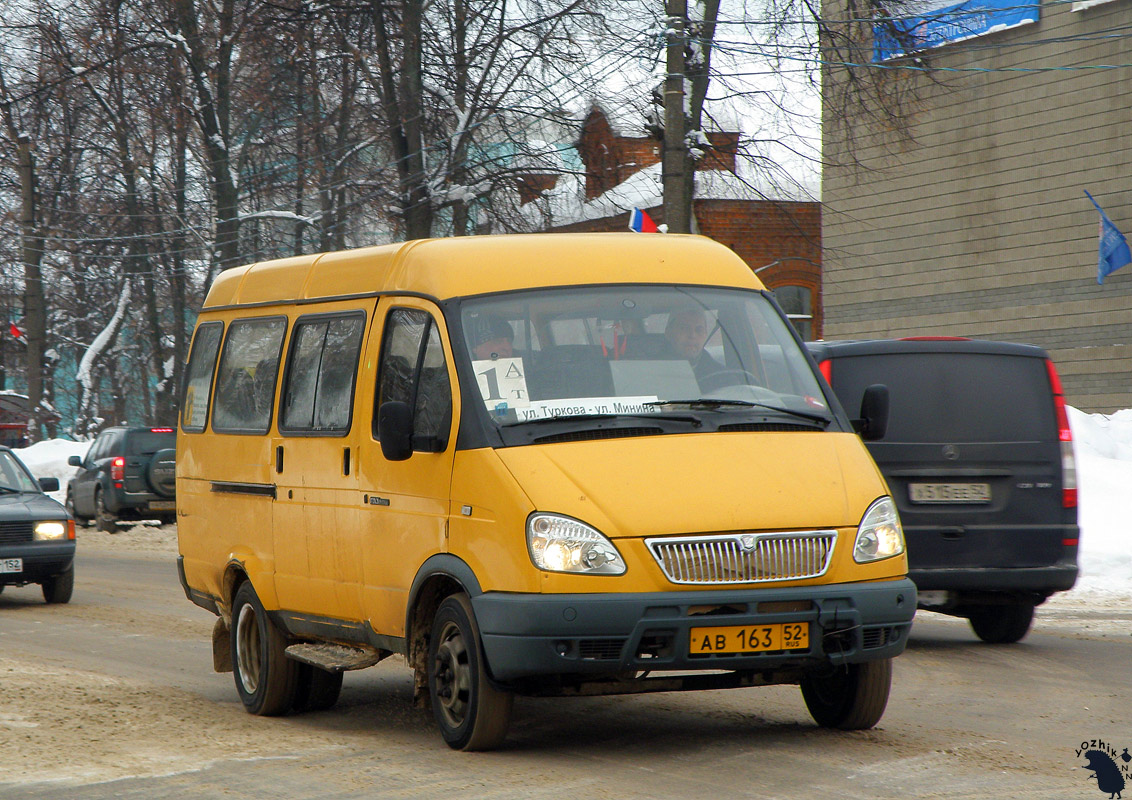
[801,659,892,731]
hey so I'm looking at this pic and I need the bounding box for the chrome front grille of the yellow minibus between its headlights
[645,531,838,584]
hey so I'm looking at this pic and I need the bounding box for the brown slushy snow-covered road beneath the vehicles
[0,528,1132,800]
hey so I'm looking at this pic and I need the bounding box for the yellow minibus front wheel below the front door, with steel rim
[428,594,514,750]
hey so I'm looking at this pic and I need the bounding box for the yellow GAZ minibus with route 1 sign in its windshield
[177,233,916,750]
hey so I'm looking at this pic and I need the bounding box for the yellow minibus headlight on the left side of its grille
[526,514,625,575]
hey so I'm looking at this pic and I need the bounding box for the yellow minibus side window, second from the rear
[213,317,286,433]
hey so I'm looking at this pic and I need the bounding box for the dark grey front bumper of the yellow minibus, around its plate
[472,578,916,682]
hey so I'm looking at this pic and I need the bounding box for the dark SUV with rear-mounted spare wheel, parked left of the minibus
[67,428,177,533]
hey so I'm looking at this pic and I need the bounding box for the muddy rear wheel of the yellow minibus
[231,580,299,716]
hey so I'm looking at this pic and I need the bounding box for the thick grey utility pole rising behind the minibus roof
[661,0,692,233]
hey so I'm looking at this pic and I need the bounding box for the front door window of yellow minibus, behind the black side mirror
[374,309,452,453]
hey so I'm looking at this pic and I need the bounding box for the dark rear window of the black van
[833,353,1057,444]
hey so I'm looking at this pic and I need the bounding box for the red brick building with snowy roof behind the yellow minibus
[520,105,822,338]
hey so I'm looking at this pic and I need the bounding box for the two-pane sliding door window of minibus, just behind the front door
[280,312,366,433]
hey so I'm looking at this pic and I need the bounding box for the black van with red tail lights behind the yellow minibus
[807,338,1078,643]
